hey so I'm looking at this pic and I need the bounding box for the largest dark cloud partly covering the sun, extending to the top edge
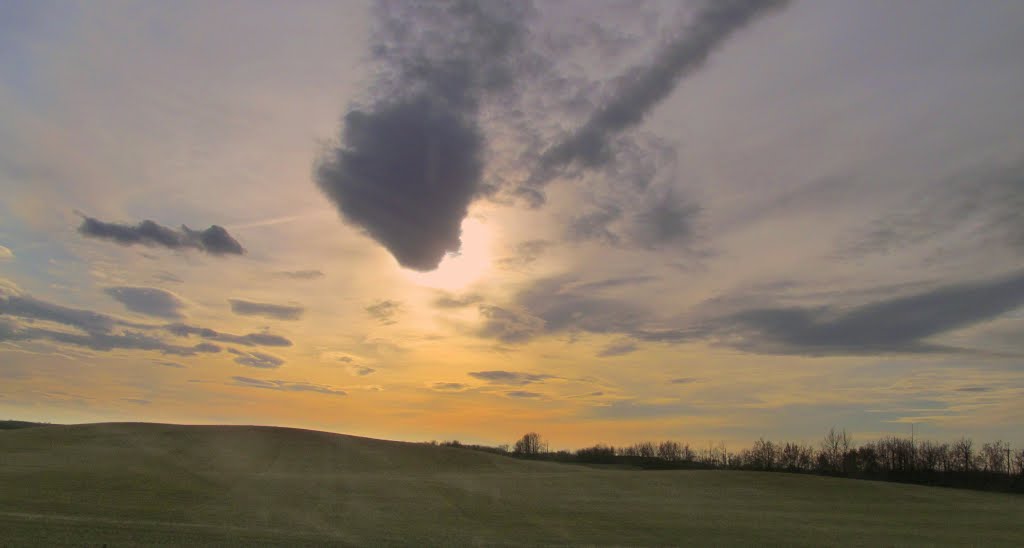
[315,0,531,270]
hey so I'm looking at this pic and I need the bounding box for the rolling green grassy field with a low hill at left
[0,424,1024,546]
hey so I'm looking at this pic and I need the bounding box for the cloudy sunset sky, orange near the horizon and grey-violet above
[0,0,1024,449]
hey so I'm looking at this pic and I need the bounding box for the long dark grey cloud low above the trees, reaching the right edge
[716,272,1024,355]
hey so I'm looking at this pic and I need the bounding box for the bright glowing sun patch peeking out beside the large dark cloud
[403,217,494,291]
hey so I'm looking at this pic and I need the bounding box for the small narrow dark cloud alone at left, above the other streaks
[78,216,245,255]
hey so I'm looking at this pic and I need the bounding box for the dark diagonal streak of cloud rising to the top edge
[530,0,786,184]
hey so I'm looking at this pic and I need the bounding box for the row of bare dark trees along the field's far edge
[430,428,1024,493]
